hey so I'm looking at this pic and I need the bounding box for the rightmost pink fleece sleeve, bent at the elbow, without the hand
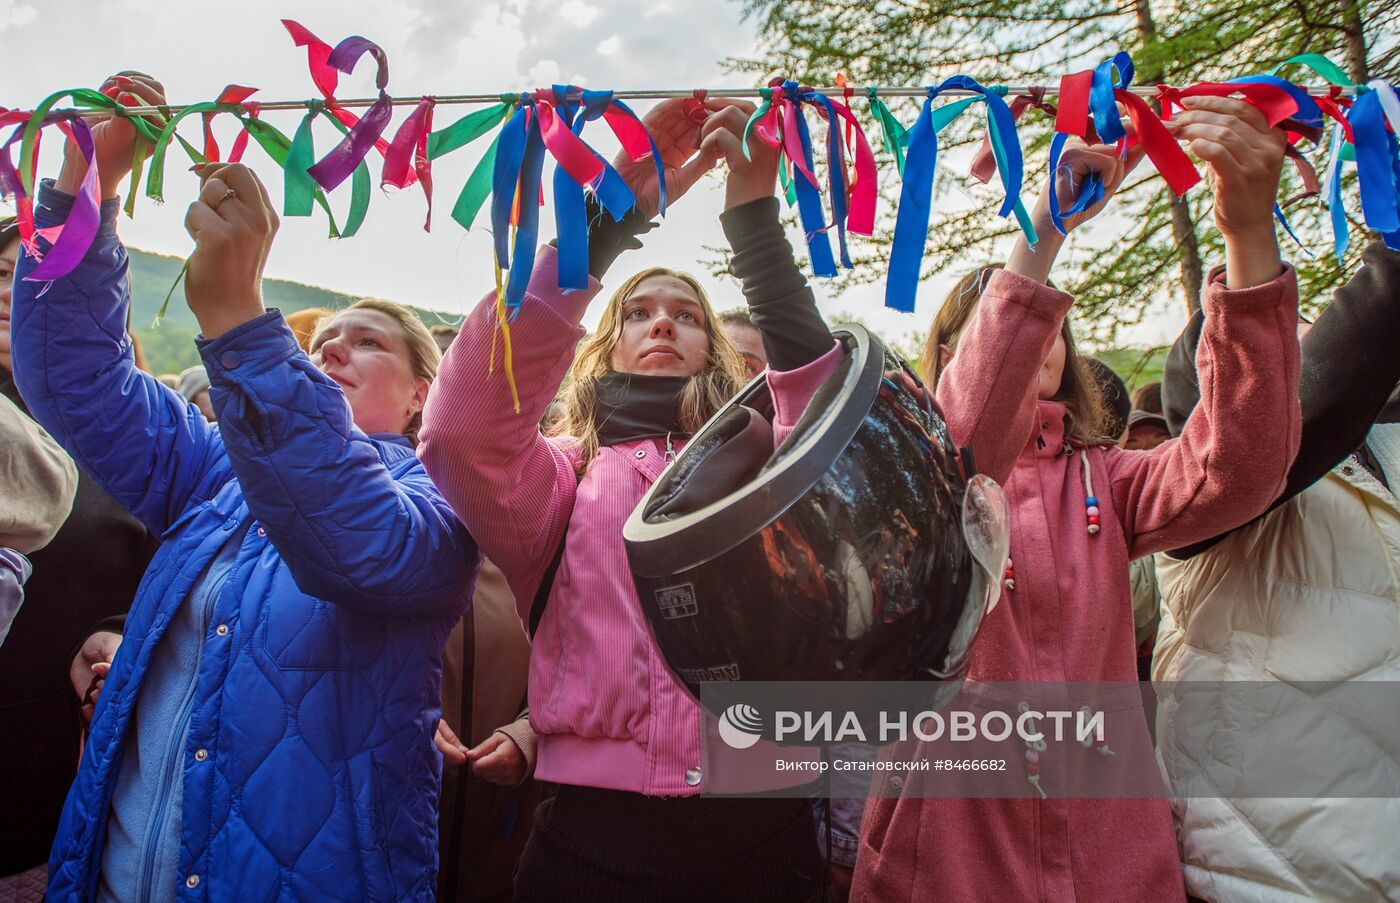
[1105,267,1302,559]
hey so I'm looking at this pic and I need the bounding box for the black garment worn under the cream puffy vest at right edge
[1162,242,1400,559]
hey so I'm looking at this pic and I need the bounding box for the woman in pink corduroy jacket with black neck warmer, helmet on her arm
[419,101,830,902]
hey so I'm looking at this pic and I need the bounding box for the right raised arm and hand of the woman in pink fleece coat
[1106,98,1301,557]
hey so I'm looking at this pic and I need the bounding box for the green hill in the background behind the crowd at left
[126,248,456,374]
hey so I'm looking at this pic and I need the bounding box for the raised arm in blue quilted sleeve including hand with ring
[173,164,480,617]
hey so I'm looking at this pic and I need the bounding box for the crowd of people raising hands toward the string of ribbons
[0,73,1400,903]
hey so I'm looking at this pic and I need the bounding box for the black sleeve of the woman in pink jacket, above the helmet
[720,197,834,371]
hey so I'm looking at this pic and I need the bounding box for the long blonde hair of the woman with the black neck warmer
[546,266,748,473]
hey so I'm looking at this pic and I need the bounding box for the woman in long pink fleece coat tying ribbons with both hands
[853,98,1301,903]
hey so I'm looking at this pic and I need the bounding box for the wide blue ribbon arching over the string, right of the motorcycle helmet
[885,76,1036,314]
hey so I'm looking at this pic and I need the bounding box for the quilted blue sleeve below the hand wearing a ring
[200,311,480,619]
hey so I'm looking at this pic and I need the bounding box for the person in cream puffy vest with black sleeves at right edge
[1152,242,1400,903]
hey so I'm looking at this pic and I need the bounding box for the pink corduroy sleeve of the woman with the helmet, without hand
[419,246,601,617]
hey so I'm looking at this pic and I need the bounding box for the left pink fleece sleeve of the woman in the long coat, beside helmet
[937,270,1074,483]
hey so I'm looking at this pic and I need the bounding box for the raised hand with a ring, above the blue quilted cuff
[185,162,277,339]
